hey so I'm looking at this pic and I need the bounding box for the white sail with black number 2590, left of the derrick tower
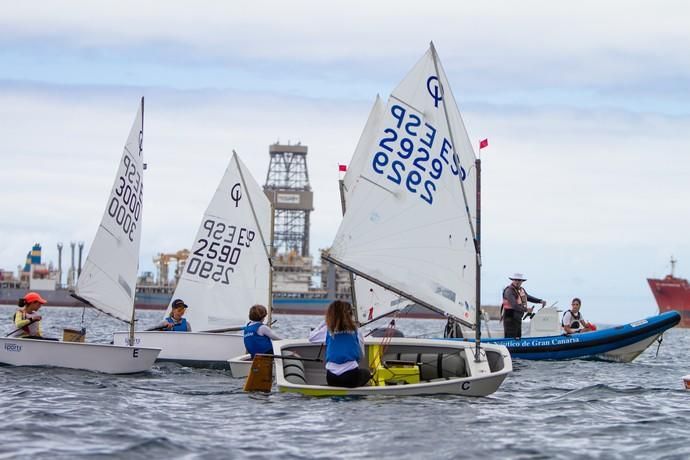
[168,152,271,331]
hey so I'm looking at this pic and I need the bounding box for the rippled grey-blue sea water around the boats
[0,307,690,460]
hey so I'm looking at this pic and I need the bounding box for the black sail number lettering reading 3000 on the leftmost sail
[108,154,144,241]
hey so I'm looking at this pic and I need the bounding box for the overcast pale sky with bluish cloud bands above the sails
[0,0,690,323]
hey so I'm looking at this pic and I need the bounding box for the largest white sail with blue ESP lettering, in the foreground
[330,48,477,324]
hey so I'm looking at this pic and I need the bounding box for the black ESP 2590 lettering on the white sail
[185,219,256,284]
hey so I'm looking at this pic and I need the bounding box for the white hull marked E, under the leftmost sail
[0,338,161,374]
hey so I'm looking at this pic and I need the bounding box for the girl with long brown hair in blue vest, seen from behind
[309,300,371,388]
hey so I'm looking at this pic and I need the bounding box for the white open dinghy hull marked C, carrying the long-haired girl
[273,338,513,396]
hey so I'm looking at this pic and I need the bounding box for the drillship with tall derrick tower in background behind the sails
[0,143,350,314]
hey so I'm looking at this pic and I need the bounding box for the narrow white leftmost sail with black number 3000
[75,98,144,322]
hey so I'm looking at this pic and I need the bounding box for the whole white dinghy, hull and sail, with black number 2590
[113,152,272,368]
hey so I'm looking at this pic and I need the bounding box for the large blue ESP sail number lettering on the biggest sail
[371,105,467,204]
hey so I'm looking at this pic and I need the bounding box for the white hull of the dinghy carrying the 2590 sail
[113,331,246,369]
